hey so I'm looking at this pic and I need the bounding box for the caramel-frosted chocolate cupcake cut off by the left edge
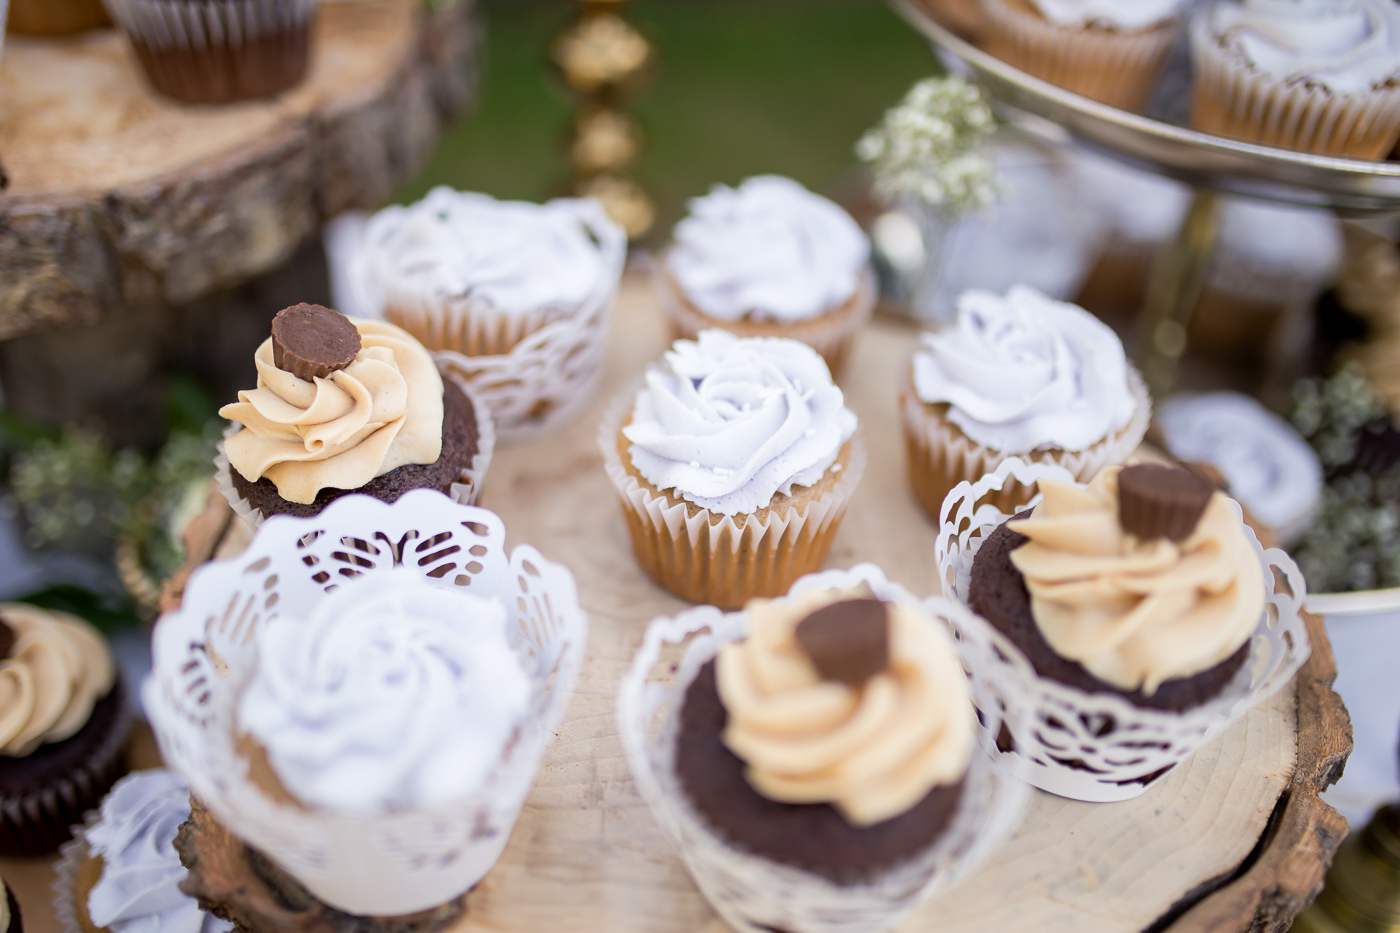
[0,602,129,856]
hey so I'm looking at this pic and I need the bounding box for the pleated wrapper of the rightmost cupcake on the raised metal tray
[1191,17,1400,160]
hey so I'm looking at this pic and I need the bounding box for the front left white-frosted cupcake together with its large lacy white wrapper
[144,490,588,916]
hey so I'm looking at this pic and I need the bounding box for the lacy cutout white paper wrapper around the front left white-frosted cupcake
[144,489,588,916]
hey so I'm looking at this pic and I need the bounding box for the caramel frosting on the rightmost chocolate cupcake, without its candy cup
[1009,467,1264,695]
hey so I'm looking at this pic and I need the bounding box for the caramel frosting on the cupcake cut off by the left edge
[0,602,116,758]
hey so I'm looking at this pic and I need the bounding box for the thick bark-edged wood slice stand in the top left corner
[0,0,476,339]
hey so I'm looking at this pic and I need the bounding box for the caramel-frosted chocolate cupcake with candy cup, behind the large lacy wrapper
[217,304,494,525]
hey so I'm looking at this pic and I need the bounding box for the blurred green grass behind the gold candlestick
[398,0,937,231]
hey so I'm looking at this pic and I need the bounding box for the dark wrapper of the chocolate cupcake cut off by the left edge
[0,683,132,856]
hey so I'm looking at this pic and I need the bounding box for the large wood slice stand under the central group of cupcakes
[0,275,1351,933]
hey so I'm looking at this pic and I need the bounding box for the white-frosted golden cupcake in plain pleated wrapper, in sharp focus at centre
[598,331,865,608]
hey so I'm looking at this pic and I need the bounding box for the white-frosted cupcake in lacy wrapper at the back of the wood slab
[350,188,627,431]
